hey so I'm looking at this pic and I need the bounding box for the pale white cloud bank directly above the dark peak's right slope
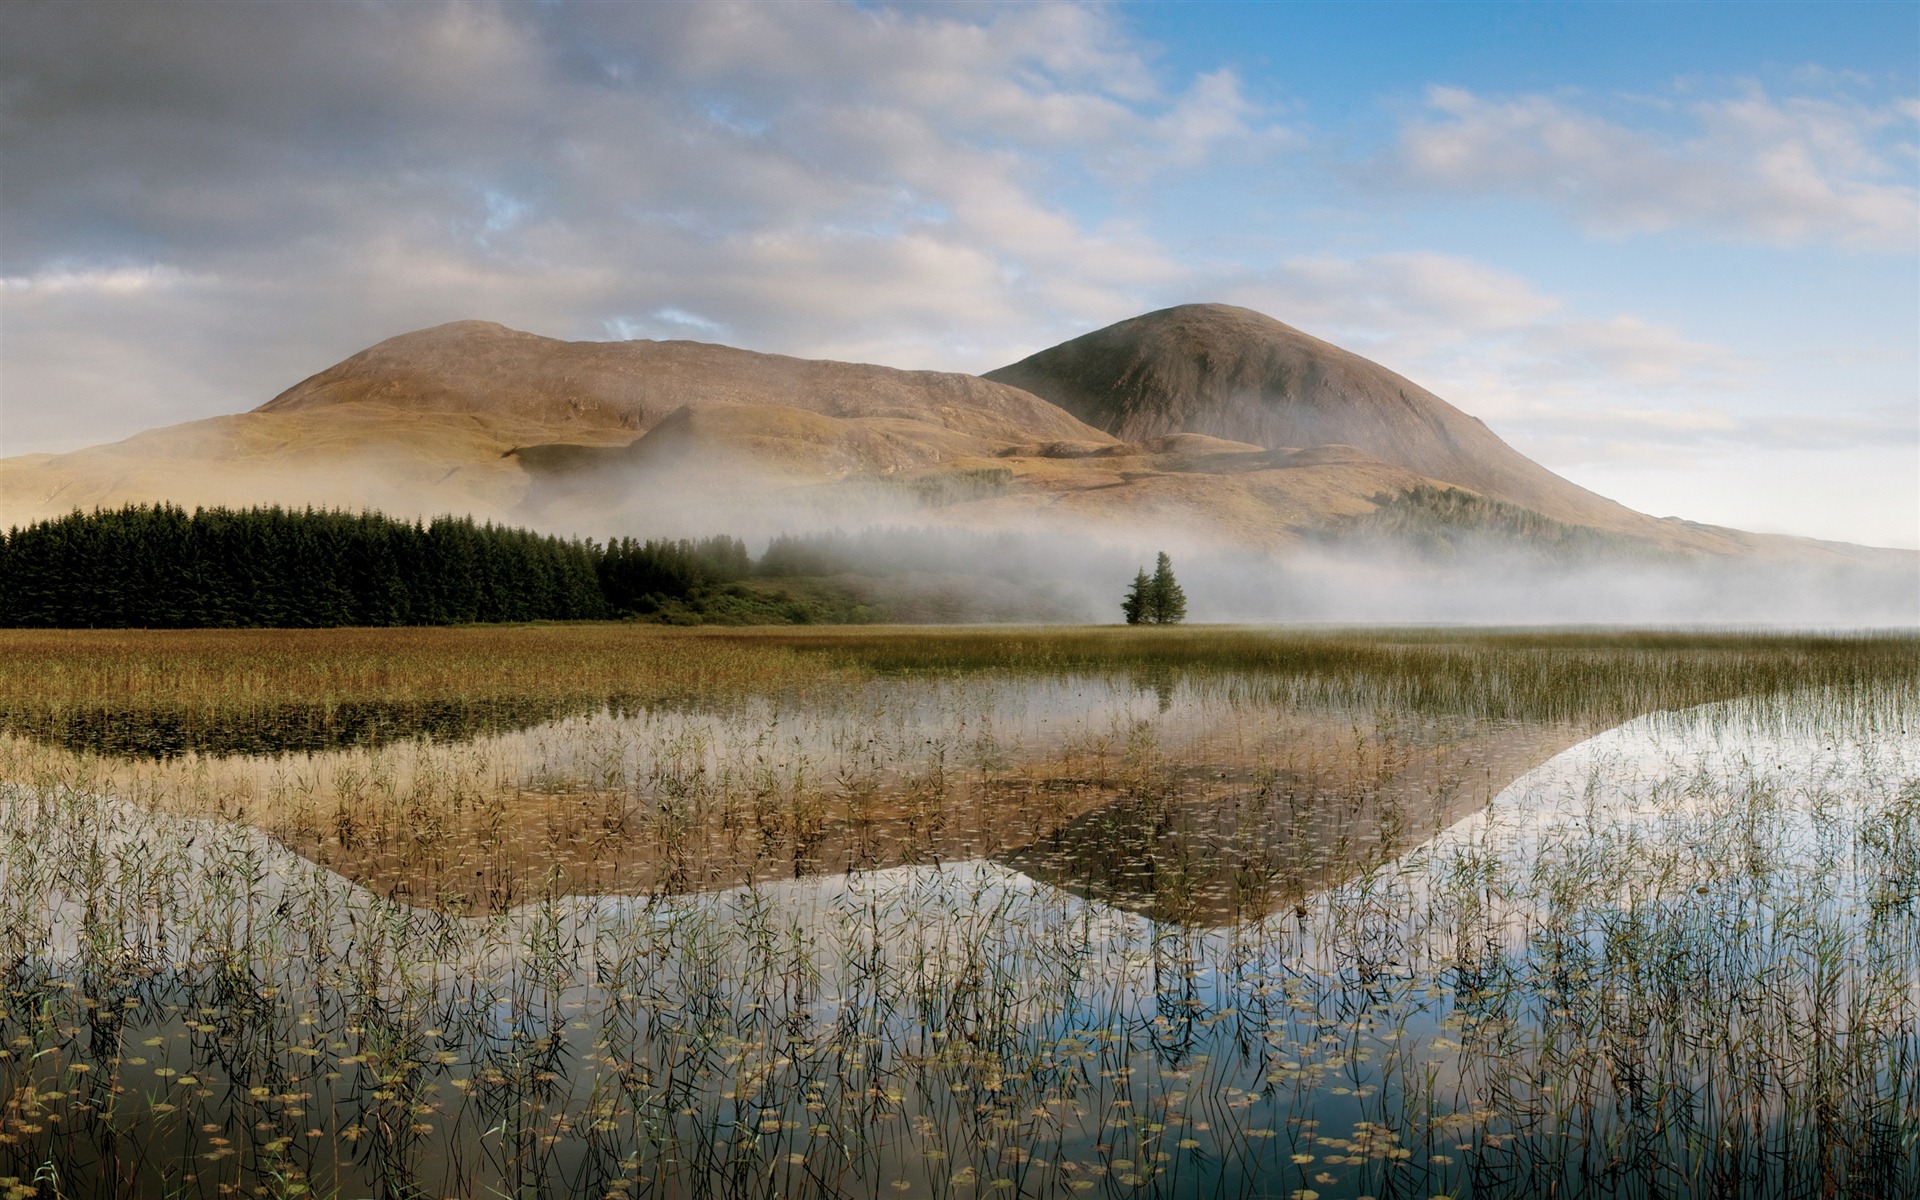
[1231,253,1920,545]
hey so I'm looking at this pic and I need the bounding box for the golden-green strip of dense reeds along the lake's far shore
[0,622,1920,724]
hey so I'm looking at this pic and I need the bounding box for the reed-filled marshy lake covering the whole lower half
[0,628,1920,1200]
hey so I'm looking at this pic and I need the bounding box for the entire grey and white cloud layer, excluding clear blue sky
[0,0,1920,541]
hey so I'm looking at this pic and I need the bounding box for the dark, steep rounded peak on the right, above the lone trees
[985,303,1653,532]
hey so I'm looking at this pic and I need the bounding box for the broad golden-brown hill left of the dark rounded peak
[0,321,1114,536]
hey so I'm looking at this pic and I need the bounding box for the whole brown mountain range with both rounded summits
[0,305,1910,576]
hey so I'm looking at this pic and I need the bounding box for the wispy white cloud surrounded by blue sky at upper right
[1377,84,1920,253]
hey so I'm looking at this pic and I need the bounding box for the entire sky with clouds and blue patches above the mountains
[0,0,1920,547]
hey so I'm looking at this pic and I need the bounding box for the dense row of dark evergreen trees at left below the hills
[0,505,751,628]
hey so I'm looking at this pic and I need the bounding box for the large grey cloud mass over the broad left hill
[0,0,1286,451]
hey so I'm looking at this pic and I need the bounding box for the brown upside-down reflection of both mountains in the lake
[0,672,1584,924]
